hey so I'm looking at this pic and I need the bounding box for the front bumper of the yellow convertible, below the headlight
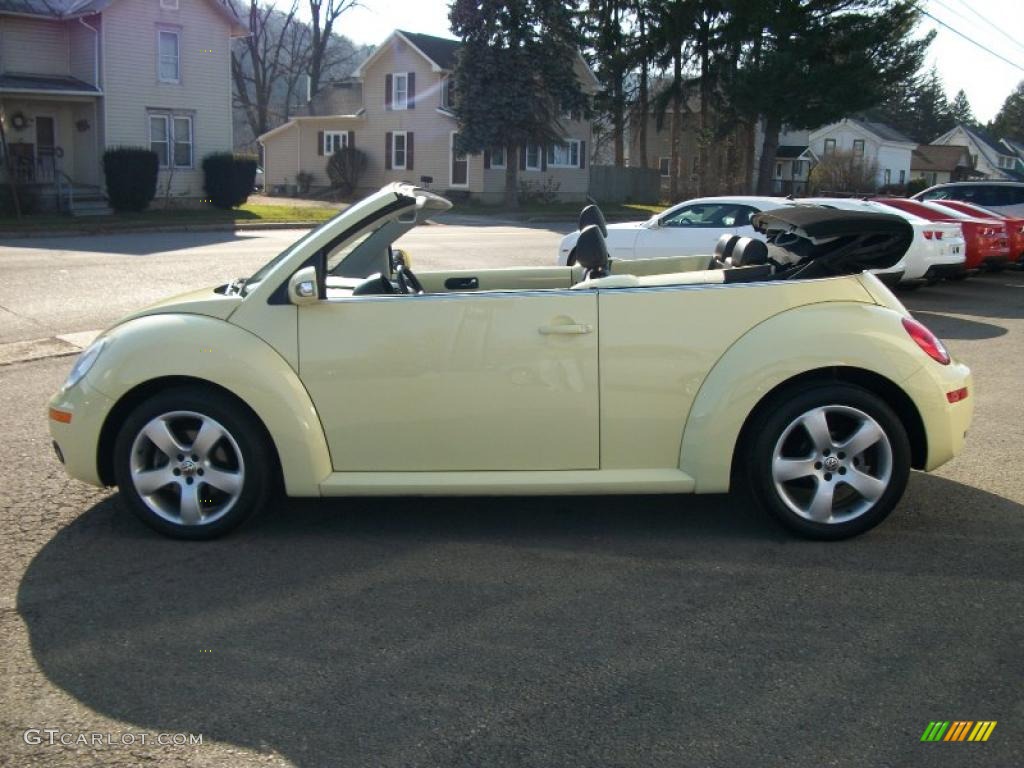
[48,380,114,487]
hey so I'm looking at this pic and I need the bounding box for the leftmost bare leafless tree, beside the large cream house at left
[231,0,302,136]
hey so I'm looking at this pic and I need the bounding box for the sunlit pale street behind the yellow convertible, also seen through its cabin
[0,224,572,344]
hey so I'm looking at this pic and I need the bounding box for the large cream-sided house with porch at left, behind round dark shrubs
[0,0,248,211]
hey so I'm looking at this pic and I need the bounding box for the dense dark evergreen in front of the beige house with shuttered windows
[449,0,589,207]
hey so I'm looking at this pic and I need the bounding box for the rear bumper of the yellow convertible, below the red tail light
[903,360,977,472]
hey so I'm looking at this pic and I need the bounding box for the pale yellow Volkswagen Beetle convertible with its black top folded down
[49,184,973,539]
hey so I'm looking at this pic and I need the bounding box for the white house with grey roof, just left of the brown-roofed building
[809,118,917,186]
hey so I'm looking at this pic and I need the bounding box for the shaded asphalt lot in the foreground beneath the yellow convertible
[0,228,1024,768]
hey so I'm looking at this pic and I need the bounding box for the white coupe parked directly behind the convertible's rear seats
[557,195,913,286]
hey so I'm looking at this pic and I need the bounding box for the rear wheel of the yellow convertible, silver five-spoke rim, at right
[745,384,910,540]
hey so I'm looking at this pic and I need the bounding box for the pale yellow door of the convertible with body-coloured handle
[298,290,599,472]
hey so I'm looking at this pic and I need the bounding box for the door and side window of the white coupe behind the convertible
[636,202,753,259]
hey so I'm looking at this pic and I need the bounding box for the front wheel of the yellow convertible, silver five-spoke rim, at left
[114,387,276,539]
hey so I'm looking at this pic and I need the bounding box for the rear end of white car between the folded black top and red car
[799,198,967,286]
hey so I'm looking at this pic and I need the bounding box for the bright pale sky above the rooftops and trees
[339,0,1024,122]
